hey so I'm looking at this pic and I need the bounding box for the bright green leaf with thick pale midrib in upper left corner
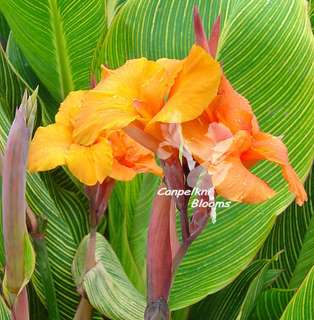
[0,0,105,100]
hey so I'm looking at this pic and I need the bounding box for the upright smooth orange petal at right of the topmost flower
[152,45,221,123]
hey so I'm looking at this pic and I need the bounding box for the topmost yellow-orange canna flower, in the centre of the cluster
[74,45,221,145]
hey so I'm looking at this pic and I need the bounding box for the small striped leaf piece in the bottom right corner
[280,267,314,320]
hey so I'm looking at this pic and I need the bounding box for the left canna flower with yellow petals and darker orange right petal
[28,91,161,186]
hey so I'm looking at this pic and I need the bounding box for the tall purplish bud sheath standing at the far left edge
[2,108,29,294]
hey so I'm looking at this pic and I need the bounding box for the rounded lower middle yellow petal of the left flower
[66,138,112,186]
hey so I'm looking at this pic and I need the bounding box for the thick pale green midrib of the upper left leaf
[48,0,74,99]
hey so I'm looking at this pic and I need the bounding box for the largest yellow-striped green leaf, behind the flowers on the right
[98,0,314,309]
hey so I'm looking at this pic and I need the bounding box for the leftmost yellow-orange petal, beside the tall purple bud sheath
[28,124,72,172]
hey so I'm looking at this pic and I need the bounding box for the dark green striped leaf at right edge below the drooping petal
[258,172,314,289]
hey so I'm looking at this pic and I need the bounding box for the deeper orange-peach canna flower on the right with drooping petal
[182,76,307,205]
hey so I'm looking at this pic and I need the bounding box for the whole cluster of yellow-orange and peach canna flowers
[29,45,307,205]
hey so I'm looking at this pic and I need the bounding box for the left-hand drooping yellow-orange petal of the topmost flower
[73,90,138,145]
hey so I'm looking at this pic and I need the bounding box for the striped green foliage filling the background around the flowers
[0,0,314,320]
